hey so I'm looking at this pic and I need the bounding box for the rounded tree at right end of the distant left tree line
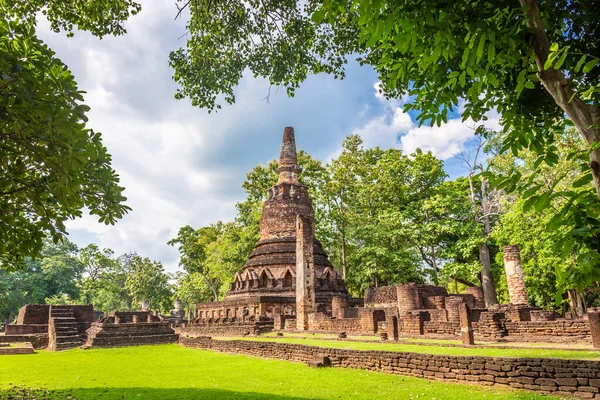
[125,256,172,312]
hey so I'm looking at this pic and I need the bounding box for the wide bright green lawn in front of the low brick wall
[0,345,552,400]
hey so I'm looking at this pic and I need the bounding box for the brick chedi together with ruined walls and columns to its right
[181,127,600,346]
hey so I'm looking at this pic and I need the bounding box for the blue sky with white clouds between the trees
[38,0,499,272]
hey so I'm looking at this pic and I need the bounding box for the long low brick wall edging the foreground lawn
[179,337,600,399]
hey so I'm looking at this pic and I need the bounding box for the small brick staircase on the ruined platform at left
[48,306,81,351]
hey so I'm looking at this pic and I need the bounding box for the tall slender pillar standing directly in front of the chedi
[296,215,315,331]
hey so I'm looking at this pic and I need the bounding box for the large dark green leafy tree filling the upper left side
[0,0,140,269]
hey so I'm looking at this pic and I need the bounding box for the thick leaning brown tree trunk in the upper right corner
[519,0,600,200]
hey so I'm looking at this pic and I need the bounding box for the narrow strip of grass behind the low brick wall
[223,336,600,360]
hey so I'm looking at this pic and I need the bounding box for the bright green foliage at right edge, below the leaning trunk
[490,129,600,305]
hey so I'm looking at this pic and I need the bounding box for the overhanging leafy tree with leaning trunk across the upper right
[171,0,600,198]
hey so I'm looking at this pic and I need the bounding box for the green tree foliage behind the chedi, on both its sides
[169,136,481,300]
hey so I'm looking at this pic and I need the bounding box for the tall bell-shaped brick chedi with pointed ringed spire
[197,127,348,322]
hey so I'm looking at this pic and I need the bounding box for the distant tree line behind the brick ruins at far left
[0,239,174,324]
